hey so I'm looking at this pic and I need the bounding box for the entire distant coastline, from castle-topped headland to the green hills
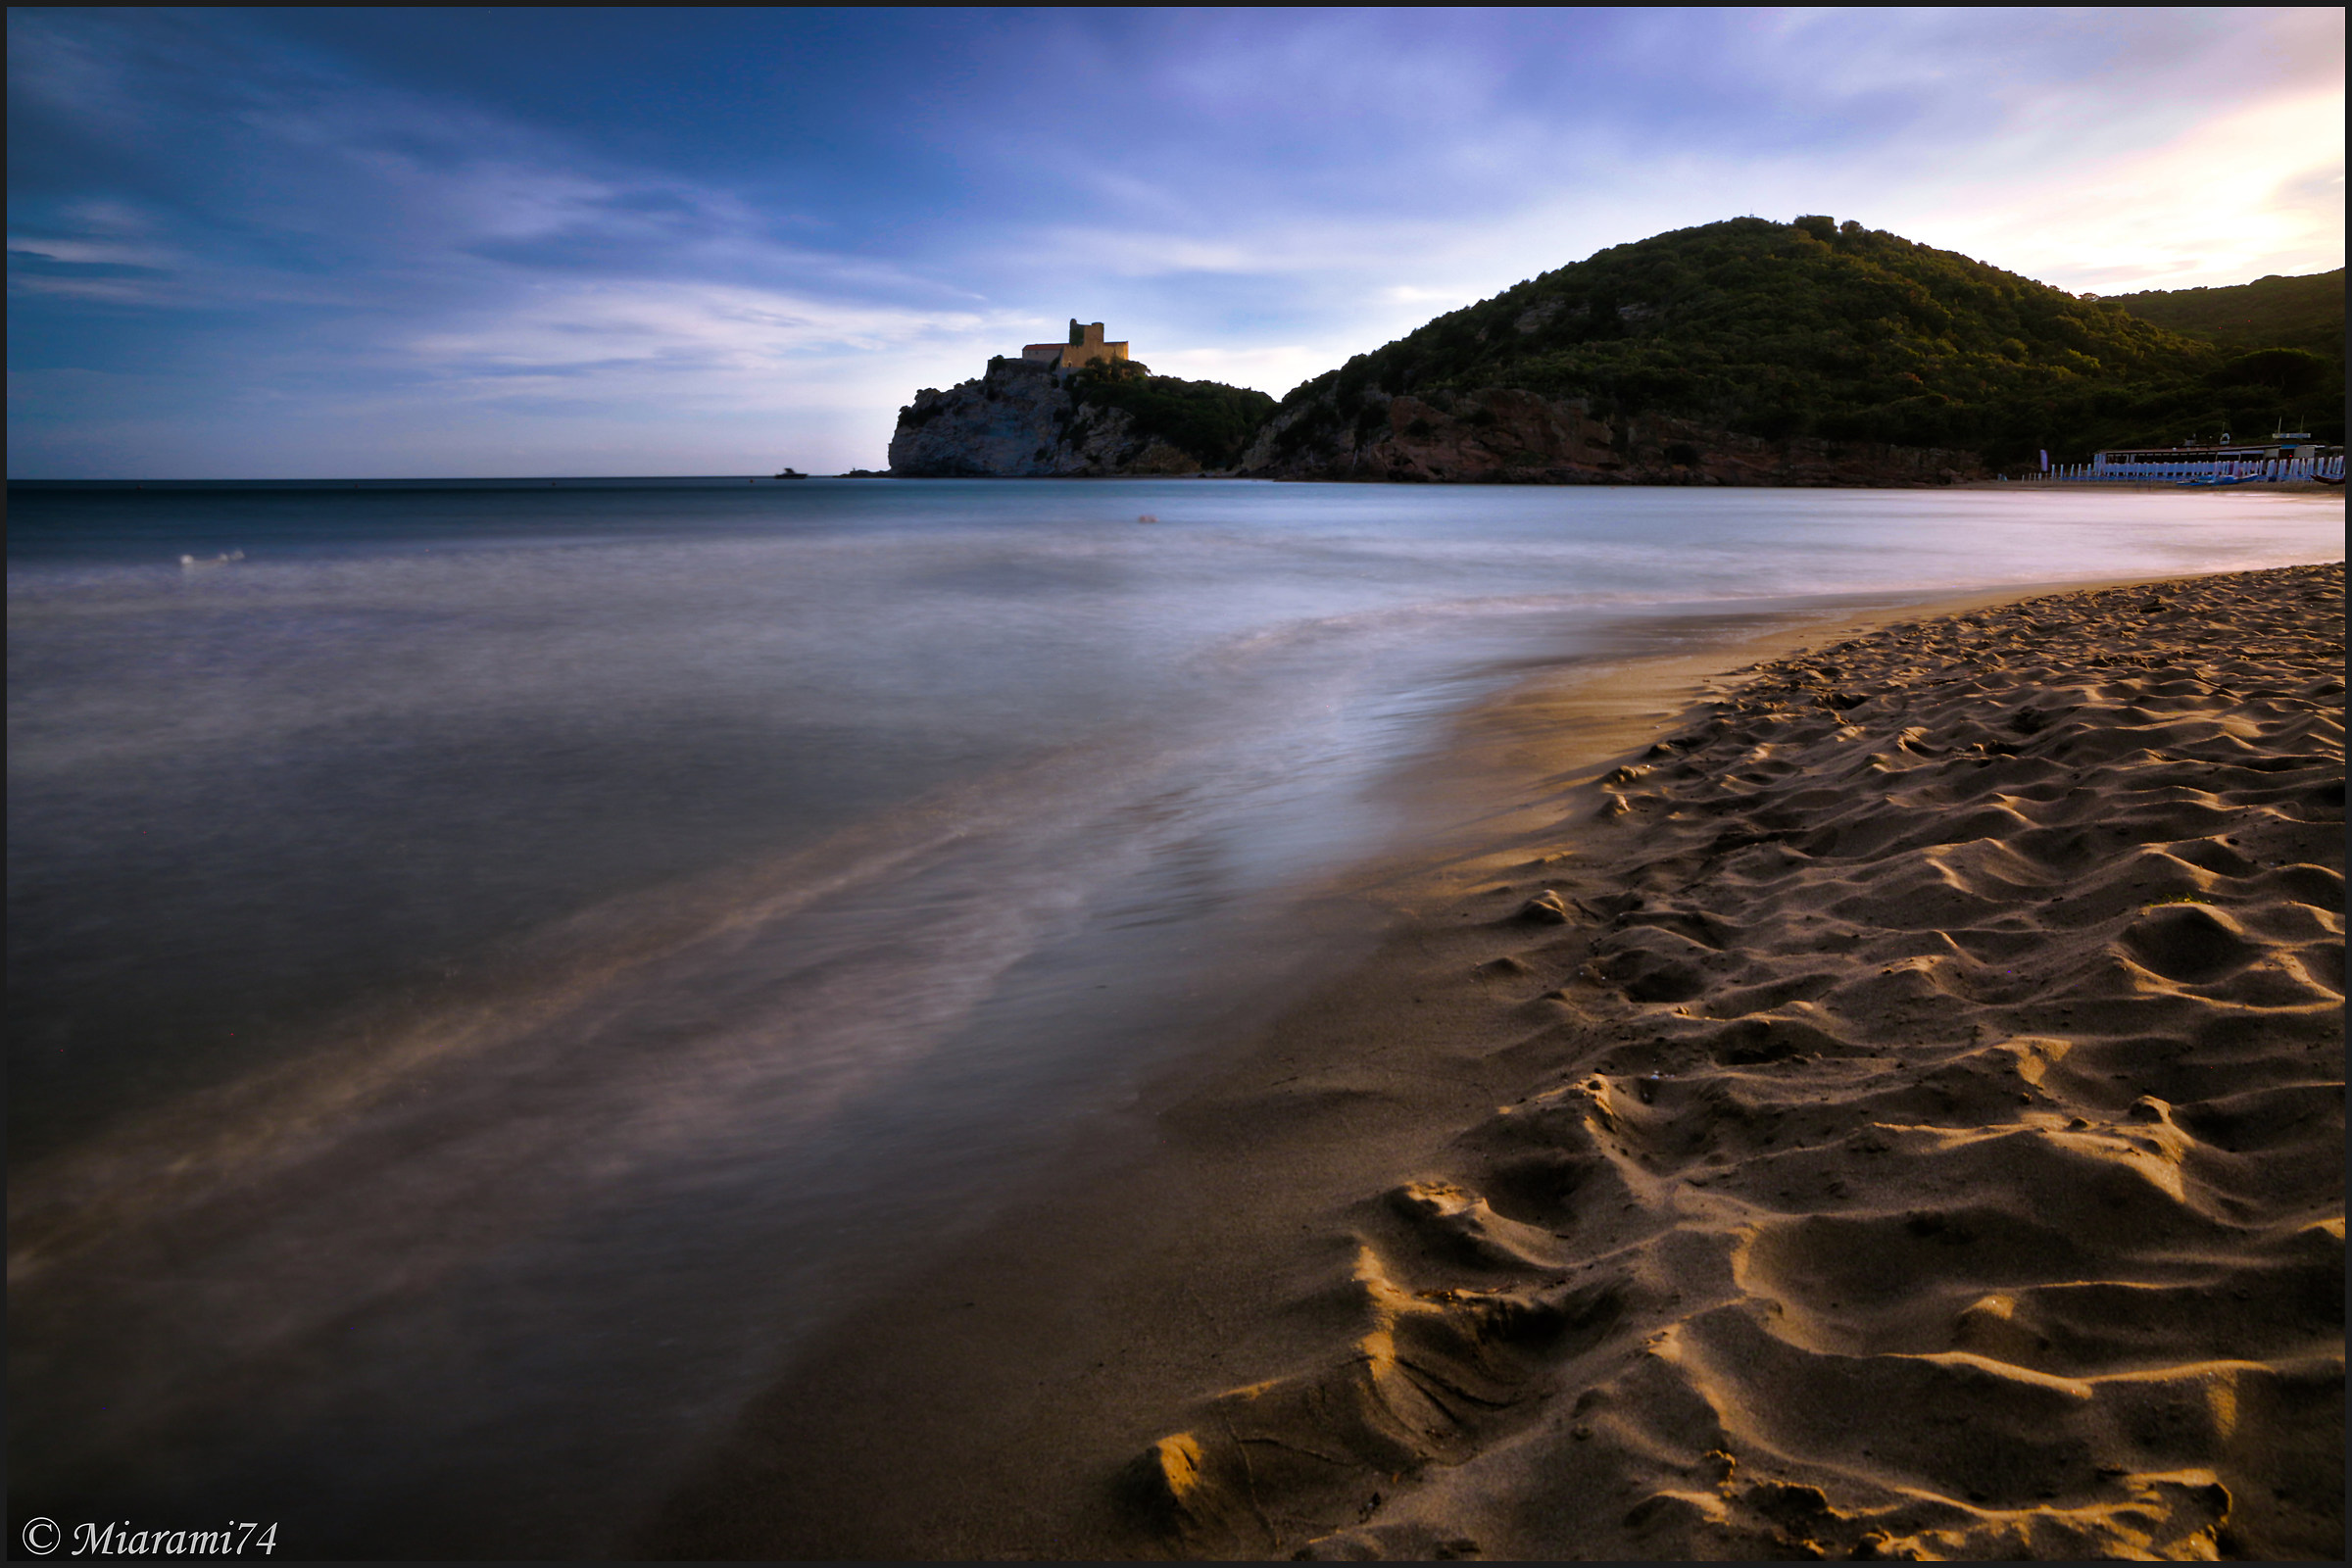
[892,217,2345,489]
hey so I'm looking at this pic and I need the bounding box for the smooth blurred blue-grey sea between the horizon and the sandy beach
[7,479,2342,1556]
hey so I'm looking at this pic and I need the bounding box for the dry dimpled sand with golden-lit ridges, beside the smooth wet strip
[1119,566,2345,1558]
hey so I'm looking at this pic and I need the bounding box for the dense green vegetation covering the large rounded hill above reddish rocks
[1280,217,2342,464]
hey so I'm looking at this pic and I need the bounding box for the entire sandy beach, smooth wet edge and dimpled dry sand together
[633,564,2345,1558]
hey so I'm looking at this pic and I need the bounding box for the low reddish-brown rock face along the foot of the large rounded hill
[1240,388,1987,487]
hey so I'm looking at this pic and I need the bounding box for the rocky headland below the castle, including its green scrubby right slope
[889,360,1275,479]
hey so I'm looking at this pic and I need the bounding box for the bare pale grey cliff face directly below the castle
[889,360,1201,479]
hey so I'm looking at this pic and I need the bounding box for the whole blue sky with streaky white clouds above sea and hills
[7,7,2345,477]
